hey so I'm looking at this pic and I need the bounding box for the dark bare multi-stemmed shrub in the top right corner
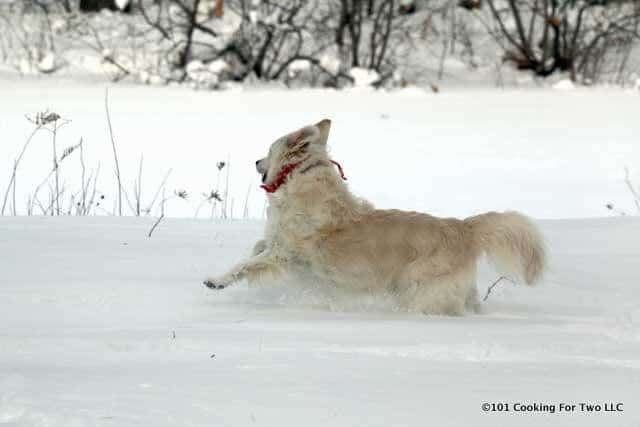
[473,0,640,82]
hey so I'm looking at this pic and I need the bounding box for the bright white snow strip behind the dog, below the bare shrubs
[0,75,640,218]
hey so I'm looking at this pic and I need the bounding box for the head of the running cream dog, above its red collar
[256,119,331,183]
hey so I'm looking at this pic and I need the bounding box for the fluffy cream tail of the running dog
[464,212,546,285]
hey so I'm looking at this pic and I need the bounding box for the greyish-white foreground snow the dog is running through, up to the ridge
[0,216,640,426]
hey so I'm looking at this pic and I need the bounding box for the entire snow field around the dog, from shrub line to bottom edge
[0,80,640,427]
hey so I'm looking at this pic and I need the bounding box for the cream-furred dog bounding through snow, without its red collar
[205,120,545,315]
